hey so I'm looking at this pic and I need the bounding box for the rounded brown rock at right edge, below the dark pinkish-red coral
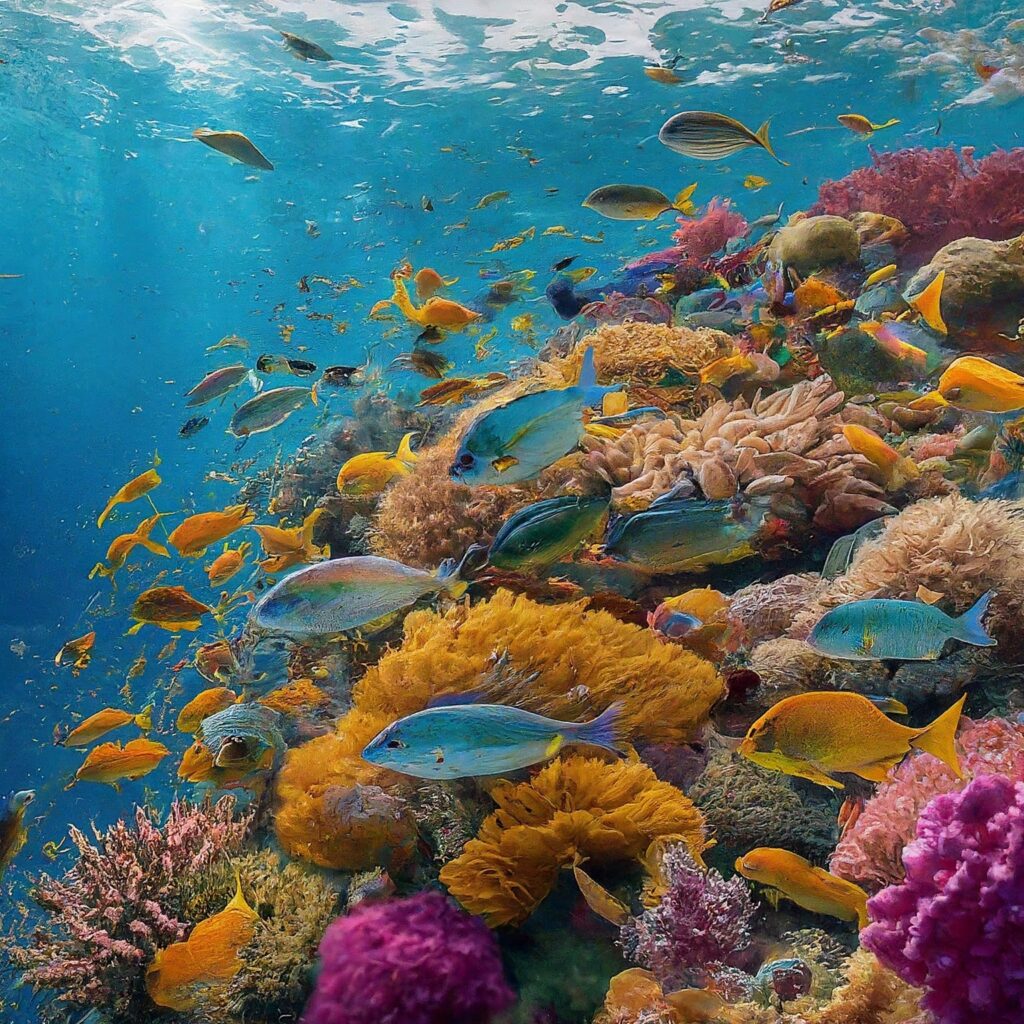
[904,237,1024,336]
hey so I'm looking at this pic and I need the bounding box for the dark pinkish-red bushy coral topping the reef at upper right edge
[810,146,1024,251]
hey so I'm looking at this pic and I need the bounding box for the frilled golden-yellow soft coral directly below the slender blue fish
[440,757,706,927]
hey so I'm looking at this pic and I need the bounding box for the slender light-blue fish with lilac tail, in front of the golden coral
[362,698,622,779]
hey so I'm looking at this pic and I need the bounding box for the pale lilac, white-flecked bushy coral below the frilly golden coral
[618,844,755,991]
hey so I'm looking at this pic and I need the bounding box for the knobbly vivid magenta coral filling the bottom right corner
[860,775,1024,1024]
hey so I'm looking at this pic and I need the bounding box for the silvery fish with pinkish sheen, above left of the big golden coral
[249,555,467,640]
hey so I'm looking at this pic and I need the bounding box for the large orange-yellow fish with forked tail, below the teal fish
[739,691,967,790]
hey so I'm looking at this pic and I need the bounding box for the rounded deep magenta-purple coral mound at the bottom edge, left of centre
[302,892,515,1024]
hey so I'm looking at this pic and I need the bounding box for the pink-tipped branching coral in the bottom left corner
[7,797,251,1024]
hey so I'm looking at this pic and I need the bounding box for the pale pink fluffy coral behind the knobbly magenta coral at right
[829,718,1024,890]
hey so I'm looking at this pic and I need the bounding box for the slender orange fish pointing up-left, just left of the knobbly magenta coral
[736,846,867,928]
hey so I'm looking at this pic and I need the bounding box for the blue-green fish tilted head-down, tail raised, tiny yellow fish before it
[451,348,623,486]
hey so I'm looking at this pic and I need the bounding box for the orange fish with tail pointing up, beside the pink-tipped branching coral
[145,876,259,1013]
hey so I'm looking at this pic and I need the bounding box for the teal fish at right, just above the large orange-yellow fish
[807,591,995,662]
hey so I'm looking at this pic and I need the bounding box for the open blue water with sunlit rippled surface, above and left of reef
[0,0,1024,1020]
